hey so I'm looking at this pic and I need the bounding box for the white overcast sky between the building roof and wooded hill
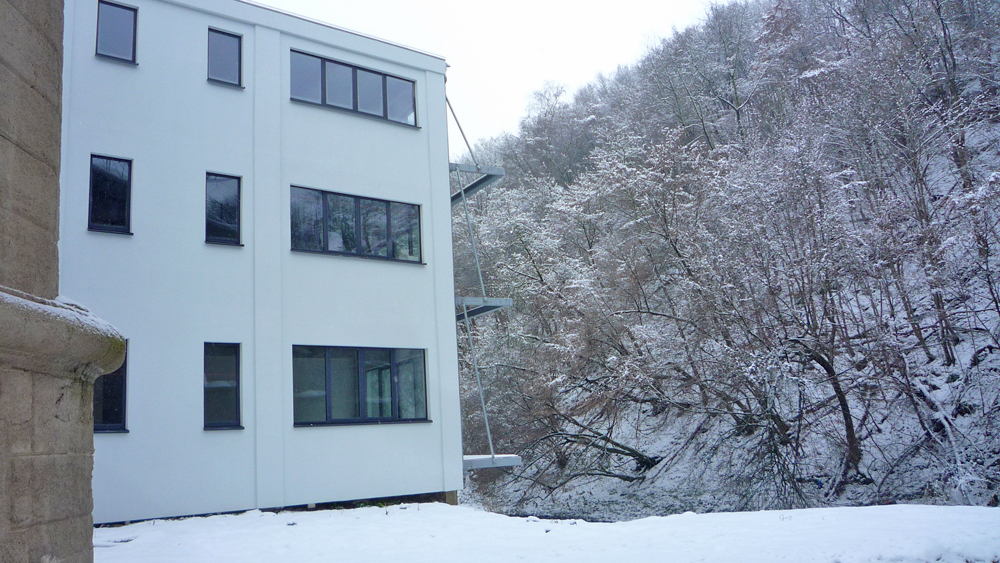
[255,0,710,155]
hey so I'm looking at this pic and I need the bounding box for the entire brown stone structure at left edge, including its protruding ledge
[0,0,125,563]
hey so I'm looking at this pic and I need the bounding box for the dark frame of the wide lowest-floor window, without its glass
[292,344,432,428]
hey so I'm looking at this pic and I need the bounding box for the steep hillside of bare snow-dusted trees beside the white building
[454,0,1000,518]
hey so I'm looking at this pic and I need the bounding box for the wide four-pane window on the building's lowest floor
[292,346,427,426]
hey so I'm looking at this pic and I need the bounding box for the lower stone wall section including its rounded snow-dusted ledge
[0,286,125,563]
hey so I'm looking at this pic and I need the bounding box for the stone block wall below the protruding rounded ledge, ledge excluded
[0,367,93,563]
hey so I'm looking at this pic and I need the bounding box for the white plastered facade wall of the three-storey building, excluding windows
[60,0,462,522]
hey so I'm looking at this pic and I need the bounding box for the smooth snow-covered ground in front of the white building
[94,504,1000,563]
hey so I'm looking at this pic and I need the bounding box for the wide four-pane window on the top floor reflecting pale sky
[290,51,417,126]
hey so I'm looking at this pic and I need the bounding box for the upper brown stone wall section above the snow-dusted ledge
[0,0,63,299]
